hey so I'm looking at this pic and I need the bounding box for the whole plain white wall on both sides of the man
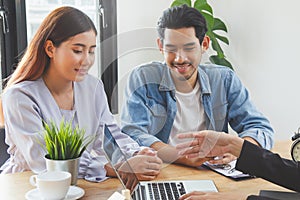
[117,0,300,140]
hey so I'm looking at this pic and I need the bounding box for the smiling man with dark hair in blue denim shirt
[121,5,273,166]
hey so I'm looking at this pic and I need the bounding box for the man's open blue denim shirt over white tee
[121,62,274,149]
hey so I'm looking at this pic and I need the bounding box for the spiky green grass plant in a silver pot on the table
[43,119,93,185]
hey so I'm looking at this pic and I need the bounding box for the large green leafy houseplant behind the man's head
[171,0,233,69]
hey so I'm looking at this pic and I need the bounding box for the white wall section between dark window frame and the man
[115,0,172,121]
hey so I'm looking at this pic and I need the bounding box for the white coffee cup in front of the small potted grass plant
[29,171,71,200]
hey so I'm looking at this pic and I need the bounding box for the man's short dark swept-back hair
[157,4,207,44]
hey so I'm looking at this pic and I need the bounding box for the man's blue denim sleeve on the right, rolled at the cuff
[225,71,274,149]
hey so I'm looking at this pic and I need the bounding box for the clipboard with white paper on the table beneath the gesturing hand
[203,160,255,180]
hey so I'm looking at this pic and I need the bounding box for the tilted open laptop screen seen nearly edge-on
[103,124,139,192]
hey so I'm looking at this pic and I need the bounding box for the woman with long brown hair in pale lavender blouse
[1,7,162,181]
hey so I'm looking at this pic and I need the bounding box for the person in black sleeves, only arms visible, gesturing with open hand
[176,131,300,200]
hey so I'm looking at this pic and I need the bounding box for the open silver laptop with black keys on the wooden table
[103,125,218,200]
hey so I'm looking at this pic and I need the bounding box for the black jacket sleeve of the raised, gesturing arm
[236,141,300,192]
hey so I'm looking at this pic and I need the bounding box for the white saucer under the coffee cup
[25,185,84,200]
